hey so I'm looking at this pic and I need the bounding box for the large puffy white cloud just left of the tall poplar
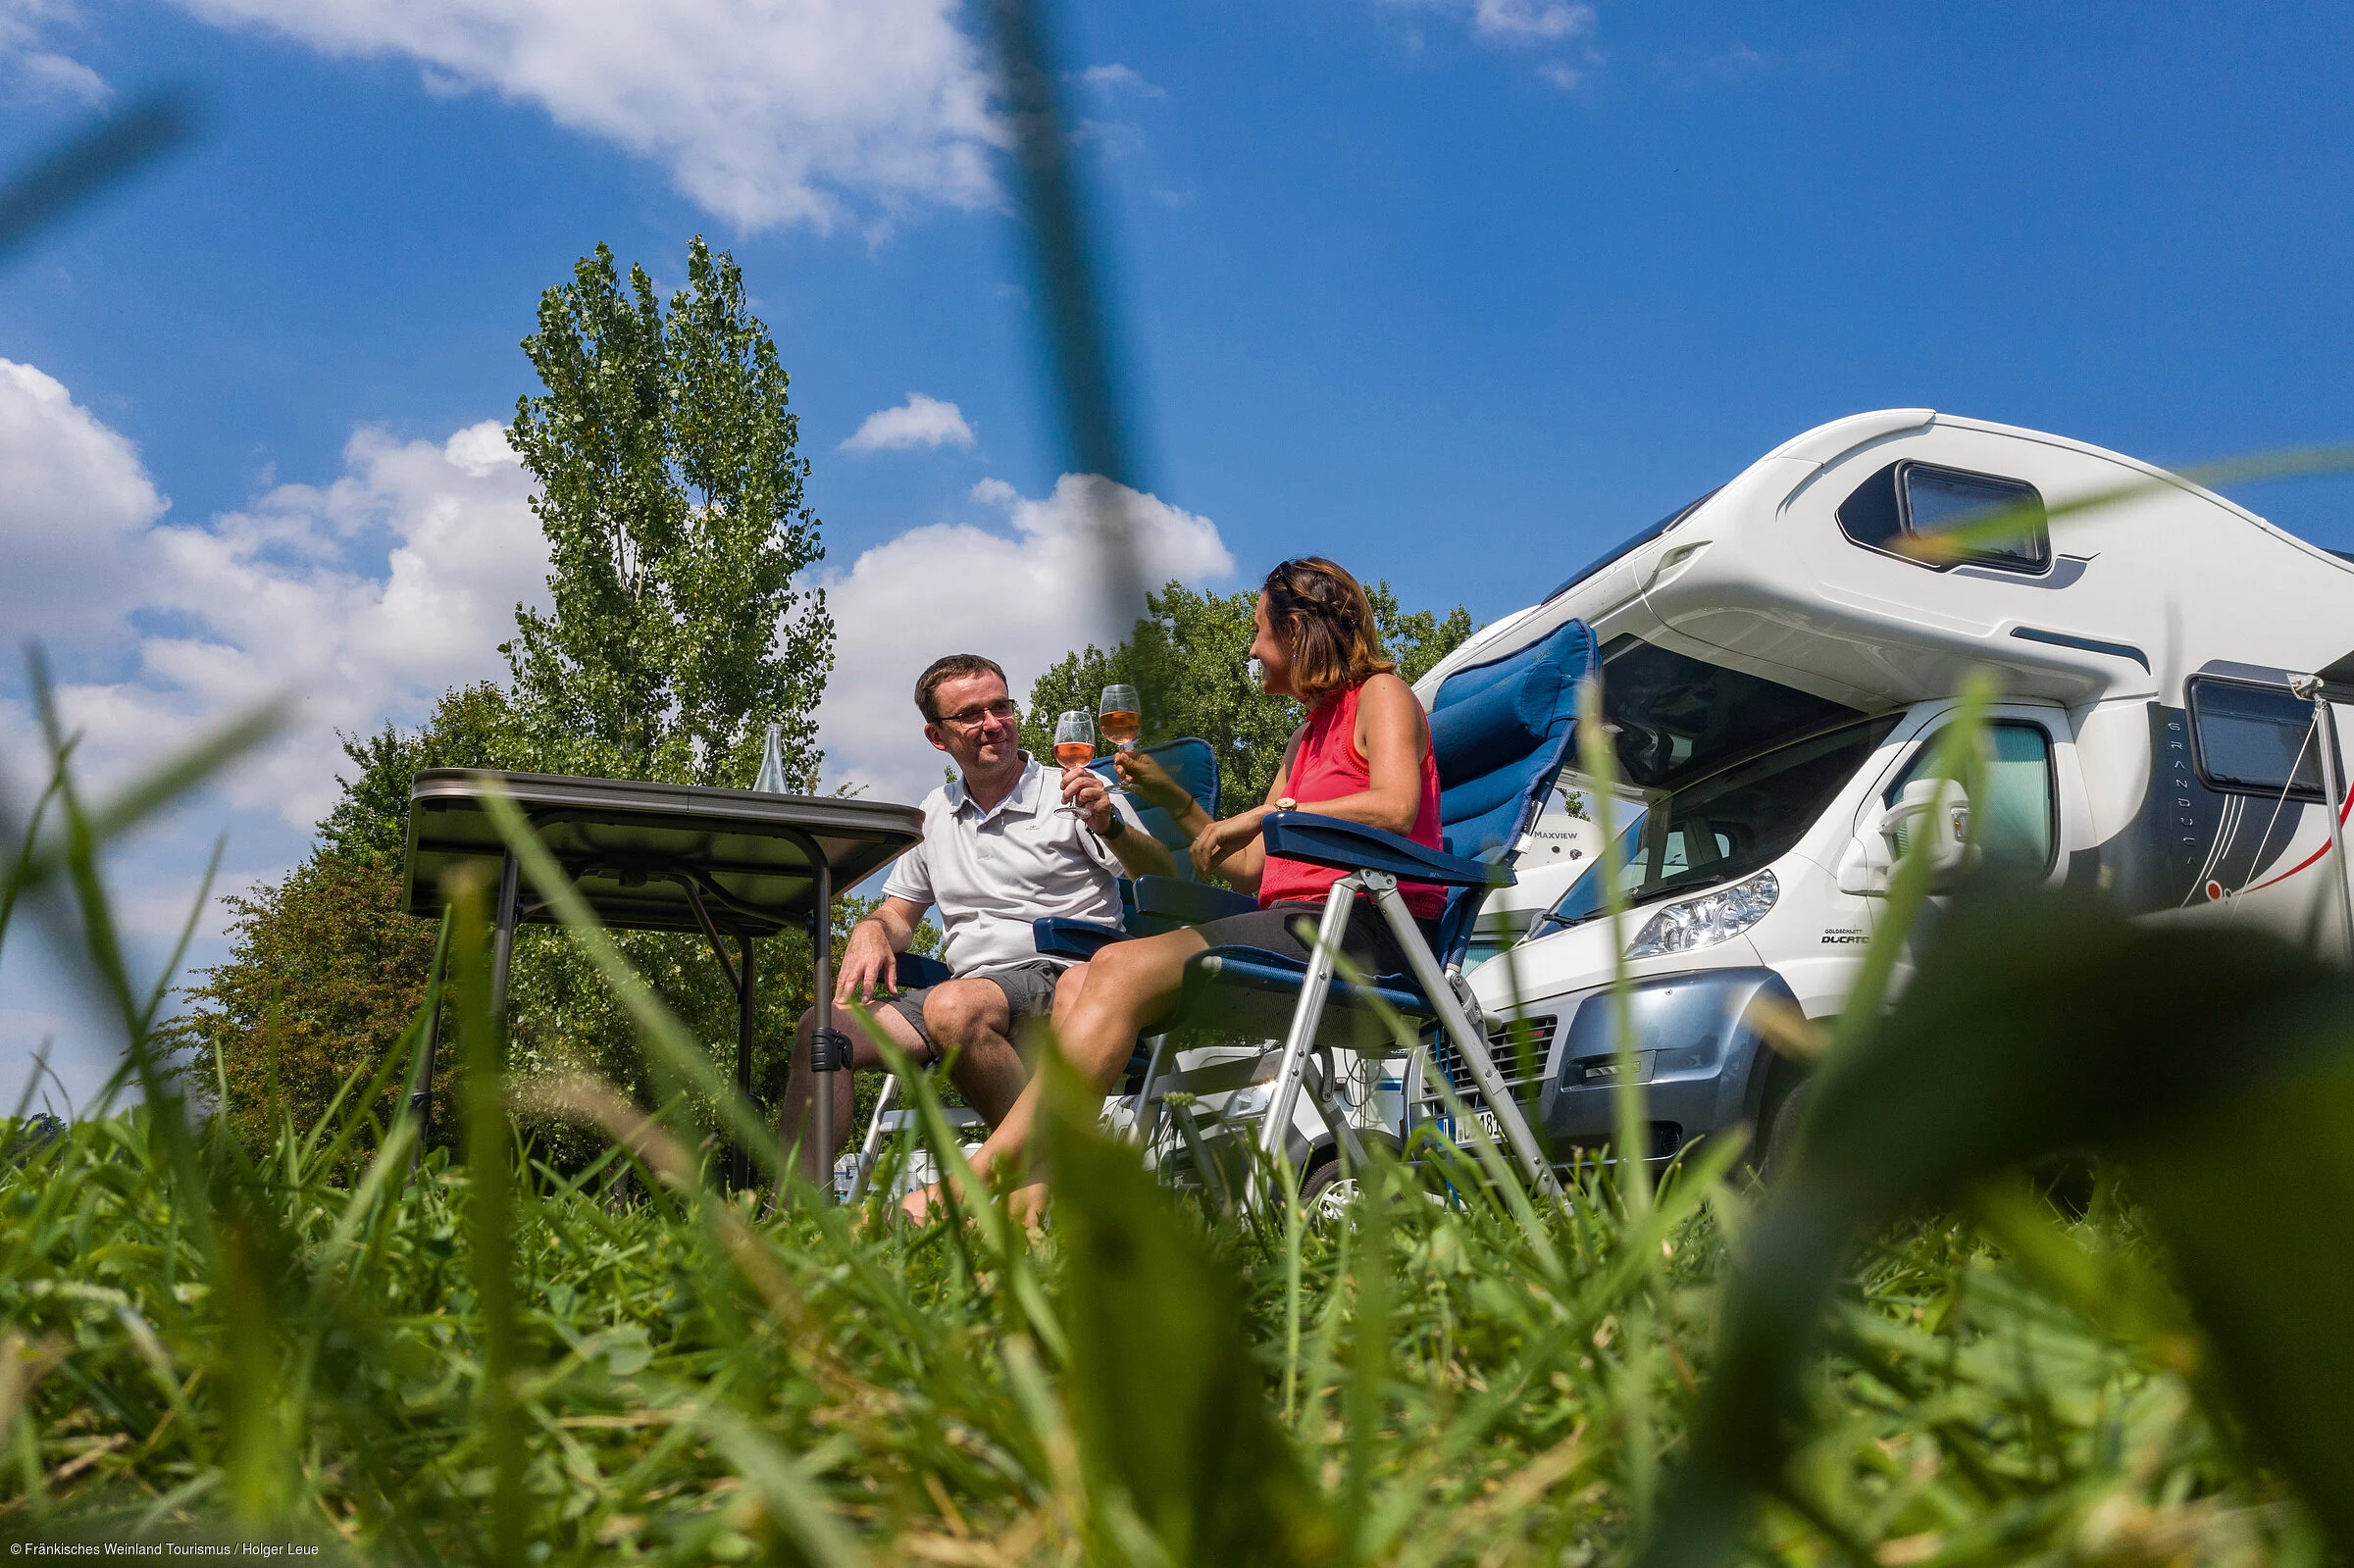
[0,404,546,829]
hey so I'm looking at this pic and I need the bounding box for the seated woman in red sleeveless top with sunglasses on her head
[906,556,1446,1217]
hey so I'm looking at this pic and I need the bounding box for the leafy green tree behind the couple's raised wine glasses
[1022,582,1473,815]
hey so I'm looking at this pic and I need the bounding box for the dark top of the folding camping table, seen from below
[407,768,923,937]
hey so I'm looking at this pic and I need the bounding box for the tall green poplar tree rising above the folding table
[499,237,834,788]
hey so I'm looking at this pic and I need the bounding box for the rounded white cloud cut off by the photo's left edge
[0,360,165,645]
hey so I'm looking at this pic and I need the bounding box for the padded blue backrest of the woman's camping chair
[1431,622,1596,965]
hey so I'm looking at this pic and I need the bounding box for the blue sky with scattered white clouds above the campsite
[0,0,2354,1087]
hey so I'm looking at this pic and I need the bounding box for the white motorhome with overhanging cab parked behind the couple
[1414,410,2354,1156]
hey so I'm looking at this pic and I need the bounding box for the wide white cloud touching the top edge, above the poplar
[163,0,1002,230]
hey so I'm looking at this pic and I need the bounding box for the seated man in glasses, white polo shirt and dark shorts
[779,654,1175,1180]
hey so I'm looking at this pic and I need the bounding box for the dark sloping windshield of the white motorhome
[1535,713,1897,935]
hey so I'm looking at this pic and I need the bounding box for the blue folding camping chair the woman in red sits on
[1041,622,1599,1191]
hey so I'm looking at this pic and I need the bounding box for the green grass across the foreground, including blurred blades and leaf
[0,668,2326,1568]
